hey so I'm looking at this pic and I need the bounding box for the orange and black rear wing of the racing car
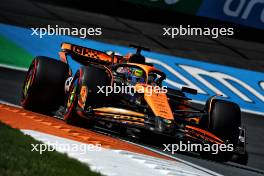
[59,43,125,64]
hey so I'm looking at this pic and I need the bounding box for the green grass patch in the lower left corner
[0,123,101,176]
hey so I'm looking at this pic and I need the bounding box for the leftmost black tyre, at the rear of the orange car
[21,56,69,114]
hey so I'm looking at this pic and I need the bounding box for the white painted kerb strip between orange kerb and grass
[22,130,220,176]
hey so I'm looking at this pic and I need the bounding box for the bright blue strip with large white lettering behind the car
[0,24,264,114]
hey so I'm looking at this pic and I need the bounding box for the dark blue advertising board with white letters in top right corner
[197,0,264,29]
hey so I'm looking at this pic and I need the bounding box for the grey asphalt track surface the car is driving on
[0,64,264,176]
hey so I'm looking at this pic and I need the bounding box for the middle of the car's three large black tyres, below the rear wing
[64,65,111,126]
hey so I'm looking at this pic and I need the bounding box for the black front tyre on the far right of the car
[201,99,241,162]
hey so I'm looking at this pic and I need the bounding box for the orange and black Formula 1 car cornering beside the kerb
[21,43,247,164]
